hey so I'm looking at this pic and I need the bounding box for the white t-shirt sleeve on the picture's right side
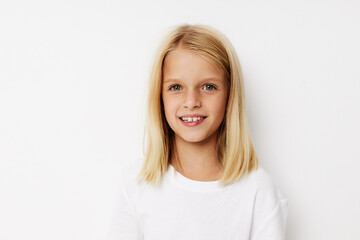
[250,182,288,240]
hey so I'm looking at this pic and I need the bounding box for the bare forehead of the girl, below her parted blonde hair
[163,48,225,81]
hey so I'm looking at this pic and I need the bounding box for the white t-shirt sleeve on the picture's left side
[106,171,143,240]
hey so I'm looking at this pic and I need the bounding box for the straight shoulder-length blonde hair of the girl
[137,24,258,185]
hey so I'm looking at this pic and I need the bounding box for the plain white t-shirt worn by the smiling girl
[107,159,287,240]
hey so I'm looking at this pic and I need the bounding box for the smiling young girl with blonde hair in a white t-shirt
[108,24,287,240]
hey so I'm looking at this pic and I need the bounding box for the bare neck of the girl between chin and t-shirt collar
[172,134,221,181]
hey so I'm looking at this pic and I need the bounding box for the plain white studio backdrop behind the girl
[0,0,360,240]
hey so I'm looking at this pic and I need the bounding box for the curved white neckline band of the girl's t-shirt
[169,164,222,190]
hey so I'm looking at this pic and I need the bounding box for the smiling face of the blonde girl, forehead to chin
[162,48,228,143]
